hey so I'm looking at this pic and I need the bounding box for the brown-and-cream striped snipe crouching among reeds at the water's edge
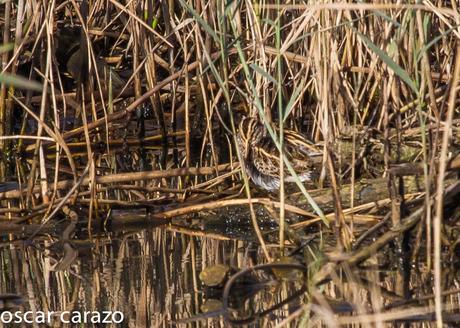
[236,117,321,190]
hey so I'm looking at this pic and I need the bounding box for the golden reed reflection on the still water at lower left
[0,224,294,327]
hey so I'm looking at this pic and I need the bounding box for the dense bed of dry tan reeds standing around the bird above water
[0,0,460,327]
